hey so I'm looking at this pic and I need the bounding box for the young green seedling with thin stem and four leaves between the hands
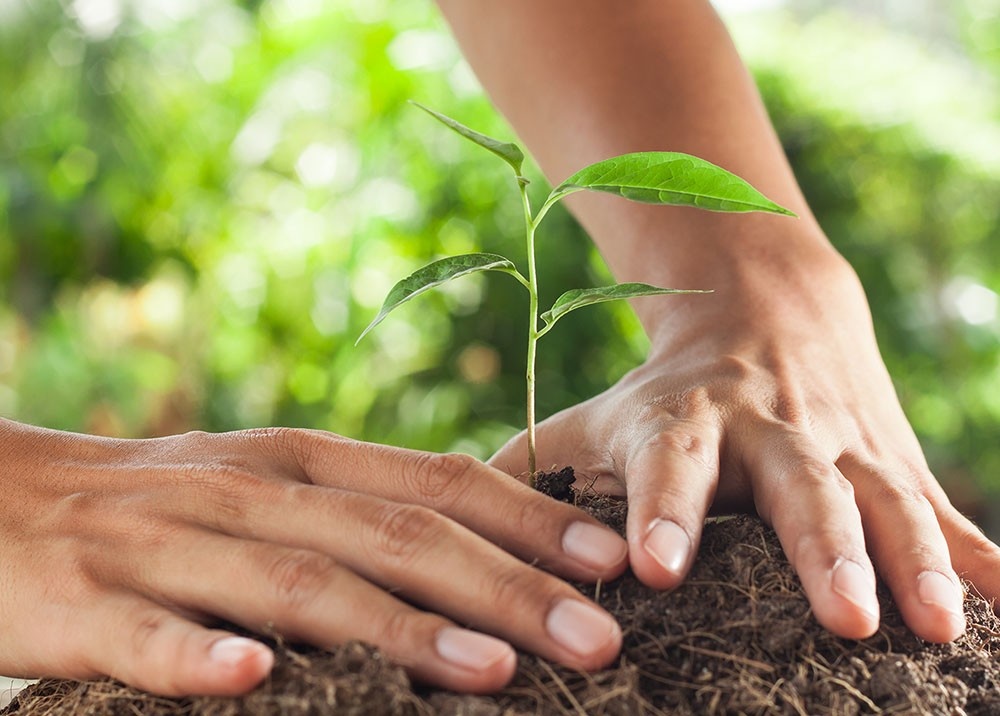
[355,102,795,484]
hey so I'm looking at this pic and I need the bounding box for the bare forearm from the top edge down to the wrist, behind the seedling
[440,0,849,338]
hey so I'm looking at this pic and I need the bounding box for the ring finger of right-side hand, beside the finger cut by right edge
[840,456,965,642]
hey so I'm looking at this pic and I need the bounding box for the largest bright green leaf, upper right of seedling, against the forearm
[546,152,795,216]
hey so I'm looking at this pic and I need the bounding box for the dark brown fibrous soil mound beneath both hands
[3,476,1000,716]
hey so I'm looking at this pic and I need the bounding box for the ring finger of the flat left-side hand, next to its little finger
[147,535,516,693]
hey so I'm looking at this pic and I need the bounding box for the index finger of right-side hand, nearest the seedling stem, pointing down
[624,420,719,589]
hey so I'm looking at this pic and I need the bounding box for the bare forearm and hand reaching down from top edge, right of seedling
[439,0,1000,642]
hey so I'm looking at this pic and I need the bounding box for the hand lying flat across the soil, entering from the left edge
[0,421,626,695]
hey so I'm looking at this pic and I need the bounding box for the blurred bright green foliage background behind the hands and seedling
[0,0,1000,534]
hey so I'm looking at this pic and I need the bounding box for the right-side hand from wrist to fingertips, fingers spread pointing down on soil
[490,256,1000,642]
